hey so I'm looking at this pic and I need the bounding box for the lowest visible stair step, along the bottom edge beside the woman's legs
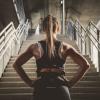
[0,93,100,100]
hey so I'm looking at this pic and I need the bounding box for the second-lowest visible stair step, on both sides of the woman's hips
[0,87,100,94]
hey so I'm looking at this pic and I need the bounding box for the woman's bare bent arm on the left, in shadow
[13,45,35,86]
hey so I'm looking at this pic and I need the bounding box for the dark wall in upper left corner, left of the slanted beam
[0,0,18,30]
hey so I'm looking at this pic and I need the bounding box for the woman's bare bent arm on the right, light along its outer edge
[66,47,90,87]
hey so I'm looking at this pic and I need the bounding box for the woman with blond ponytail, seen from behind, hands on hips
[13,15,90,100]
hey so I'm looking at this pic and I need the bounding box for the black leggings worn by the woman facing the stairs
[33,76,71,100]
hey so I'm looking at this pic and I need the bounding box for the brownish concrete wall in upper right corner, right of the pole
[66,0,100,26]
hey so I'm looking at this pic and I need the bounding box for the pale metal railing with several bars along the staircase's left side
[0,21,29,77]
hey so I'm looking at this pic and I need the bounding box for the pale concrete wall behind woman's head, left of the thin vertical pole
[31,0,61,29]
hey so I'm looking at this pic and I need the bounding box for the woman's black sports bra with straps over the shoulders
[36,40,66,71]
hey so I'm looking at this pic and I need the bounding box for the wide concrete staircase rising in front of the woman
[0,35,100,100]
